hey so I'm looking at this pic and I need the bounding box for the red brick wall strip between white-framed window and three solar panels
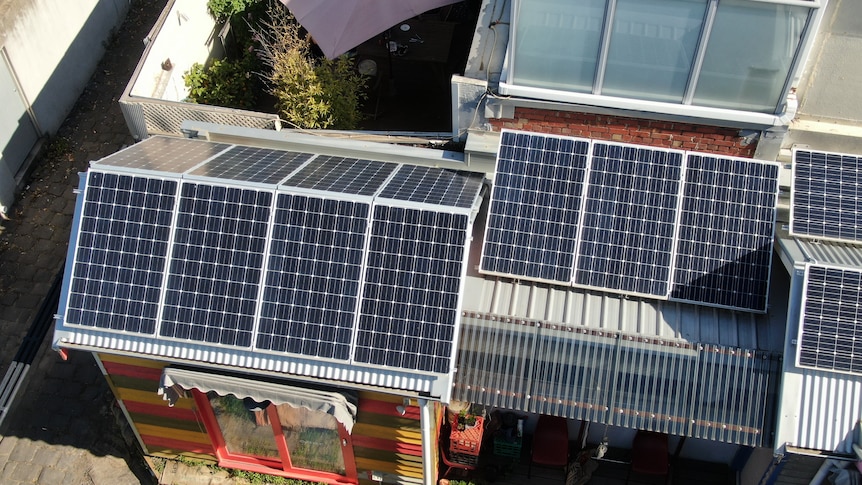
[489,108,757,158]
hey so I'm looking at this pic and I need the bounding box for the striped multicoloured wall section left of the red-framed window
[98,354,216,461]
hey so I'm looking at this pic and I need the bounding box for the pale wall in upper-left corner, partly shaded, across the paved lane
[0,0,130,212]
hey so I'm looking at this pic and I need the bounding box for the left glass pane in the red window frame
[207,392,280,460]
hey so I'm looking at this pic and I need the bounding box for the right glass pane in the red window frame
[276,404,345,475]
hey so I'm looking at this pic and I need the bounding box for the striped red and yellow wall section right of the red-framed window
[352,392,428,484]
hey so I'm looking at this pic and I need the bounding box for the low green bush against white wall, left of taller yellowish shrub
[183,54,256,109]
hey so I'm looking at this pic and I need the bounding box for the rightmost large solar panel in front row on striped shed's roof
[354,205,468,373]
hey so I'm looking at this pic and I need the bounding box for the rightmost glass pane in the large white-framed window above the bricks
[693,0,809,113]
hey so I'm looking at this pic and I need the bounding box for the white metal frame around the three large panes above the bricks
[498,0,828,127]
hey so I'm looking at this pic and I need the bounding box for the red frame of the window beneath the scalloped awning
[192,389,359,485]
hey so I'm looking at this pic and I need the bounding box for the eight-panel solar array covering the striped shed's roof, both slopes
[62,138,483,373]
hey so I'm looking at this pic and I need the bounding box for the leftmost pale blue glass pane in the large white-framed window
[511,0,605,93]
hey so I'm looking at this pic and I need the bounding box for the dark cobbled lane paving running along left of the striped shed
[0,0,166,485]
